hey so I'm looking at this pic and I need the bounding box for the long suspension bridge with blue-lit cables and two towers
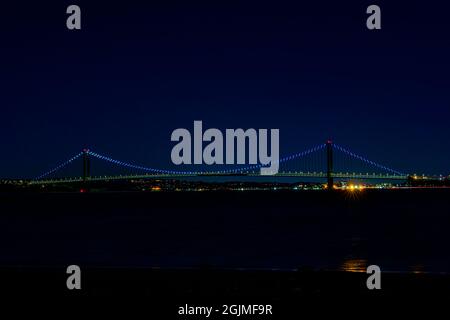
[29,141,431,188]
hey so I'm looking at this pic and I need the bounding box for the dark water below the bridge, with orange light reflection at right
[0,189,450,273]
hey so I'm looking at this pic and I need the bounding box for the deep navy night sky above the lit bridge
[0,0,450,177]
